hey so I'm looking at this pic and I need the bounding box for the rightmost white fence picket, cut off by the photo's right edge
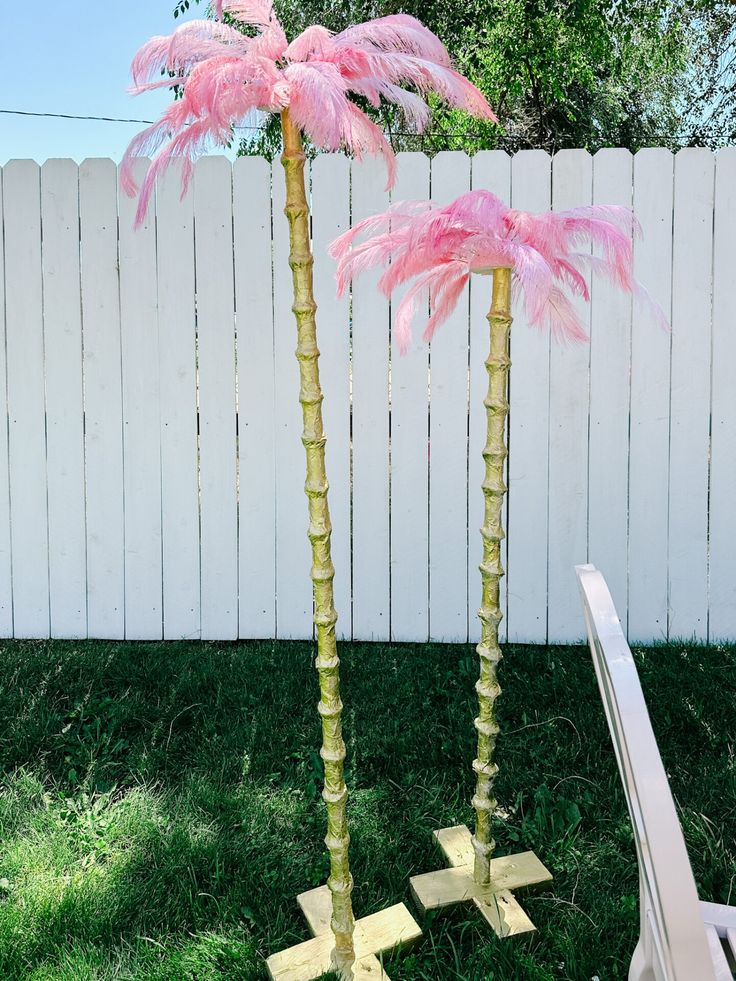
[708,147,736,641]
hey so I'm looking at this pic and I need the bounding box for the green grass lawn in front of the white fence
[0,642,736,981]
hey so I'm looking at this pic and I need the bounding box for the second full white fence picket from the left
[41,160,87,637]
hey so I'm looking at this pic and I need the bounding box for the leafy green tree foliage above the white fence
[175,0,736,155]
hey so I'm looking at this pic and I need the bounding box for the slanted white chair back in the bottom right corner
[575,565,715,981]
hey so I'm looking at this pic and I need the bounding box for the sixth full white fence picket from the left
[192,157,238,640]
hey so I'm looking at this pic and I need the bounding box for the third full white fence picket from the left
[79,160,125,640]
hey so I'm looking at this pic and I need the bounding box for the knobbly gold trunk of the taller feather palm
[281,109,355,978]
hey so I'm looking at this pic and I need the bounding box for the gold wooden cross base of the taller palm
[266,886,422,981]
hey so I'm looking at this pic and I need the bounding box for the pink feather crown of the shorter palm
[329,190,666,352]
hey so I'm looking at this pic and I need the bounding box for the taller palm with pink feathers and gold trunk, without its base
[121,0,495,977]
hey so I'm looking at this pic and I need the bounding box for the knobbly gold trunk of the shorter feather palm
[472,269,511,885]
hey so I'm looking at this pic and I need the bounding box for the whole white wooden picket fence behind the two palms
[0,148,736,642]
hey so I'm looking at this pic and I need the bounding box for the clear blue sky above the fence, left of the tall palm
[0,0,205,164]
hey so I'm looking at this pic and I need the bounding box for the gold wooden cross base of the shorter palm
[409,824,552,937]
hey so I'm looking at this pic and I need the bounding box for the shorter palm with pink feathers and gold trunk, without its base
[330,190,664,886]
